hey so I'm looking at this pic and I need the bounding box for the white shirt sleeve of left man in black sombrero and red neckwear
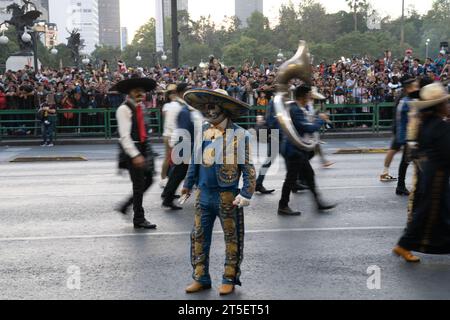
[116,104,141,159]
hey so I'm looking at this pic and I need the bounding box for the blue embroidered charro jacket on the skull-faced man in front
[184,120,256,199]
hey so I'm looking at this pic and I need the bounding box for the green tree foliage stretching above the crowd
[0,0,450,67]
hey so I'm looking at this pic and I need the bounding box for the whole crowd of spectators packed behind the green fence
[0,50,450,138]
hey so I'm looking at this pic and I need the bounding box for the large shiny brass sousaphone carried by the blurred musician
[274,41,320,151]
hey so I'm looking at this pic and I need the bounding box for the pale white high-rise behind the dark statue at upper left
[49,0,100,53]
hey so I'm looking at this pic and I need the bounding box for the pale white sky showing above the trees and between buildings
[120,0,432,40]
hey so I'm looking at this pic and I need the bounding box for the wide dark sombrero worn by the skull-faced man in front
[184,89,251,119]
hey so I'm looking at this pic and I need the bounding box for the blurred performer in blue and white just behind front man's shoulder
[162,83,203,210]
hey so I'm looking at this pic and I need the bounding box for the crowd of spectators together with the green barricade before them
[0,51,450,139]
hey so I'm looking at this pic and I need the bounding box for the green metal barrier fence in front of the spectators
[0,103,394,139]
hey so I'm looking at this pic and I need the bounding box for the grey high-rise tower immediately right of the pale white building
[98,0,121,48]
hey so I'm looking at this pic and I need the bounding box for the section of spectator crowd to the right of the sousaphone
[314,50,450,105]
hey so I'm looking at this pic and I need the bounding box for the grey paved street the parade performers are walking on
[0,139,450,299]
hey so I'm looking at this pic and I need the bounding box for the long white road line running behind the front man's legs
[0,227,405,242]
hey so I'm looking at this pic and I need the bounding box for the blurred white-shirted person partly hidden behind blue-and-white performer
[160,84,183,188]
